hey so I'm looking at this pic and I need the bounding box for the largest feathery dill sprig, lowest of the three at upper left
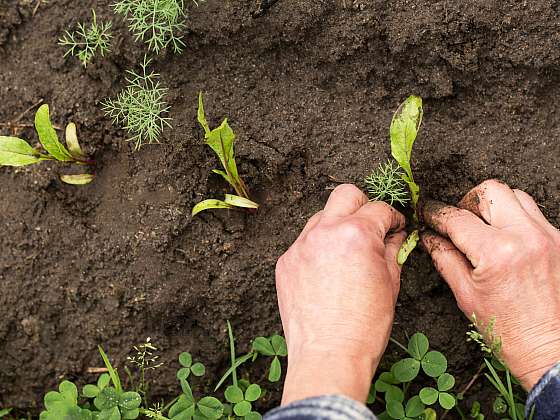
[101,57,171,150]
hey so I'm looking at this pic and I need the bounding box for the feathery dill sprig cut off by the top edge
[113,0,190,53]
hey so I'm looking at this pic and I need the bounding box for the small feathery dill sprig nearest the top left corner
[58,9,112,67]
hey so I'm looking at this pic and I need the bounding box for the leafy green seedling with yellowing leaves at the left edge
[0,105,94,185]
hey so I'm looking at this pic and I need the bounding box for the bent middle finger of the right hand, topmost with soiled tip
[459,179,527,228]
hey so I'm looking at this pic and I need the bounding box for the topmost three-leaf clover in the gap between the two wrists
[391,333,447,382]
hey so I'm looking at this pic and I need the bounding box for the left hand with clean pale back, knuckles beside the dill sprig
[276,184,406,404]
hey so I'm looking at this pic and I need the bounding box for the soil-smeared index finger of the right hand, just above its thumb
[422,201,493,267]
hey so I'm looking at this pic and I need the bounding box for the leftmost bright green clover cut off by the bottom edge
[39,381,93,420]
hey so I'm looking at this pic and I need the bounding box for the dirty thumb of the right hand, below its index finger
[420,231,473,318]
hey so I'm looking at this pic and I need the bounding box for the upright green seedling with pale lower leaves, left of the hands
[192,92,259,216]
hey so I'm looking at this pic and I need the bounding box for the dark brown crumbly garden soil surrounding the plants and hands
[0,0,560,413]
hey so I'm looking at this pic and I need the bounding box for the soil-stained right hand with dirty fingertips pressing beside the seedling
[422,180,560,390]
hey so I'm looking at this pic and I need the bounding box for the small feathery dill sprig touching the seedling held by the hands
[364,161,409,206]
